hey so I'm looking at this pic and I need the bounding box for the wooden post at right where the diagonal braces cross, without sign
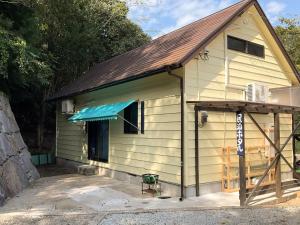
[274,113,282,198]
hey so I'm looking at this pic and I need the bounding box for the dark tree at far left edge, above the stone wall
[0,2,54,151]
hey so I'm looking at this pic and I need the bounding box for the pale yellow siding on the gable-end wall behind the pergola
[185,7,292,185]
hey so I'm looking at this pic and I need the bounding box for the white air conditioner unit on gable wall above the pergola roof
[246,84,269,102]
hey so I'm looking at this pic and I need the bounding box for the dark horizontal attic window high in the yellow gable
[227,36,265,58]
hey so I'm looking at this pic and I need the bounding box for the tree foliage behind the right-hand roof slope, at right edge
[275,18,300,71]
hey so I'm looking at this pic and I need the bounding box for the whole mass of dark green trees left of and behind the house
[0,0,150,152]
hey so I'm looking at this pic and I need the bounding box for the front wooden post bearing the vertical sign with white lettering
[236,111,246,206]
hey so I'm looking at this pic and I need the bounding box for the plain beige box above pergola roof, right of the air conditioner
[270,86,300,107]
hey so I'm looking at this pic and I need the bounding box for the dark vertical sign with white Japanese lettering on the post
[236,111,245,156]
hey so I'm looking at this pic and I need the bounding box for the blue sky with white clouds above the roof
[126,0,300,38]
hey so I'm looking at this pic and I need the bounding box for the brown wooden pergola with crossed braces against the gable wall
[187,101,300,206]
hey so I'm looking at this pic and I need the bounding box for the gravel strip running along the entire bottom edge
[0,207,300,225]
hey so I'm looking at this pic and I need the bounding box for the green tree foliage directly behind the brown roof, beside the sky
[36,0,150,90]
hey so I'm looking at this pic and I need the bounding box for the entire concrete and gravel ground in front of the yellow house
[0,166,300,225]
